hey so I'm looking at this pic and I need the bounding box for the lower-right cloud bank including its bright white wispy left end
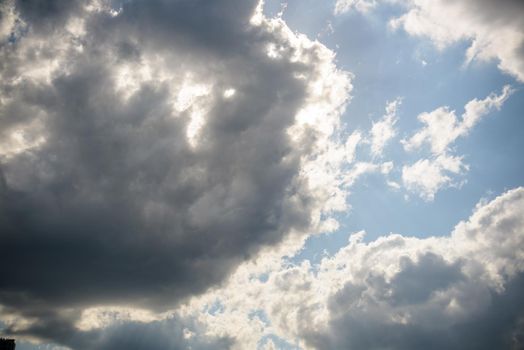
[181,188,524,349]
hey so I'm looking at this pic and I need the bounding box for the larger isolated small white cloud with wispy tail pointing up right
[401,85,514,201]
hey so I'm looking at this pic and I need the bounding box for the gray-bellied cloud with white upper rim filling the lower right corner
[296,188,524,350]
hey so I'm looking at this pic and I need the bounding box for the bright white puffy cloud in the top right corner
[335,0,524,81]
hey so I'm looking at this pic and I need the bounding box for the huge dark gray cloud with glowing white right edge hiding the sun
[0,0,351,348]
